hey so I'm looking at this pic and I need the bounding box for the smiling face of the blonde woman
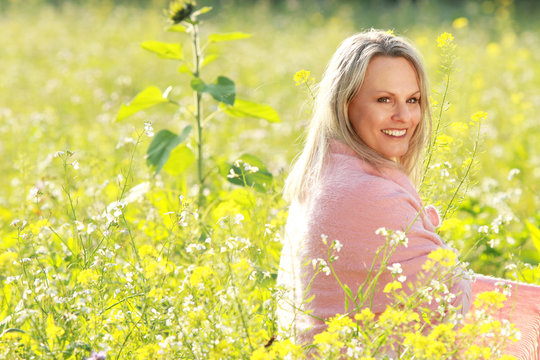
[349,56,422,161]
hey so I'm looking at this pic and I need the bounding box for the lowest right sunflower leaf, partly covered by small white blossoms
[219,154,273,193]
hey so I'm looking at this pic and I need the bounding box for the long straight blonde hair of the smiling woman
[284,29,431,200]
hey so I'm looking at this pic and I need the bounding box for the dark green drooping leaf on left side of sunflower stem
[146,125,191,175]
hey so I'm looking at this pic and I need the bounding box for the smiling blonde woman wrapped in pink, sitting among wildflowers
[278,30,540,359]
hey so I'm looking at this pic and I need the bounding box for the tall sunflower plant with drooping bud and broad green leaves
[117,1,279,206]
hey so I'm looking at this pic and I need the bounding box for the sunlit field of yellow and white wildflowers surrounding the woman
[0,0,540,359]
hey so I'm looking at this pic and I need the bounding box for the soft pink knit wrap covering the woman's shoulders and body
[278,141,540,359]
